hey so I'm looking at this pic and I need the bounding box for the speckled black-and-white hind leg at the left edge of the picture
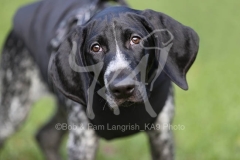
[0,34,47,144]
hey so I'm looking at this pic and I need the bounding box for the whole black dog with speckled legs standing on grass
[0,0,199,160]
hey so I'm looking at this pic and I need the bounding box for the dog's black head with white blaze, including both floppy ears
[50,7,199,110]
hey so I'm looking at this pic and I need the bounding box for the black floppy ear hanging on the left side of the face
[48,28,89,104]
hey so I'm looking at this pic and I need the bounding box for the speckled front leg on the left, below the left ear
[67,102,98,160]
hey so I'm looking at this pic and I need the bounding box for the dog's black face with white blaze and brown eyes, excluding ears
[83,9,153,107]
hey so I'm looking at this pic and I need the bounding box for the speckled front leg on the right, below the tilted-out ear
[147,89,174,160]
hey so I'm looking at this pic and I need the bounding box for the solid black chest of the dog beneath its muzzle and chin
[88,78,171,139]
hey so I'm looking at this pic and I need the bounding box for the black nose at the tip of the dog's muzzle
[109,79,135,99]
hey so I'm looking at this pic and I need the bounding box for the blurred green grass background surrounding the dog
[0,0,240,160]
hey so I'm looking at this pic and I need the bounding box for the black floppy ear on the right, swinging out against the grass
[142,10,199,90]
